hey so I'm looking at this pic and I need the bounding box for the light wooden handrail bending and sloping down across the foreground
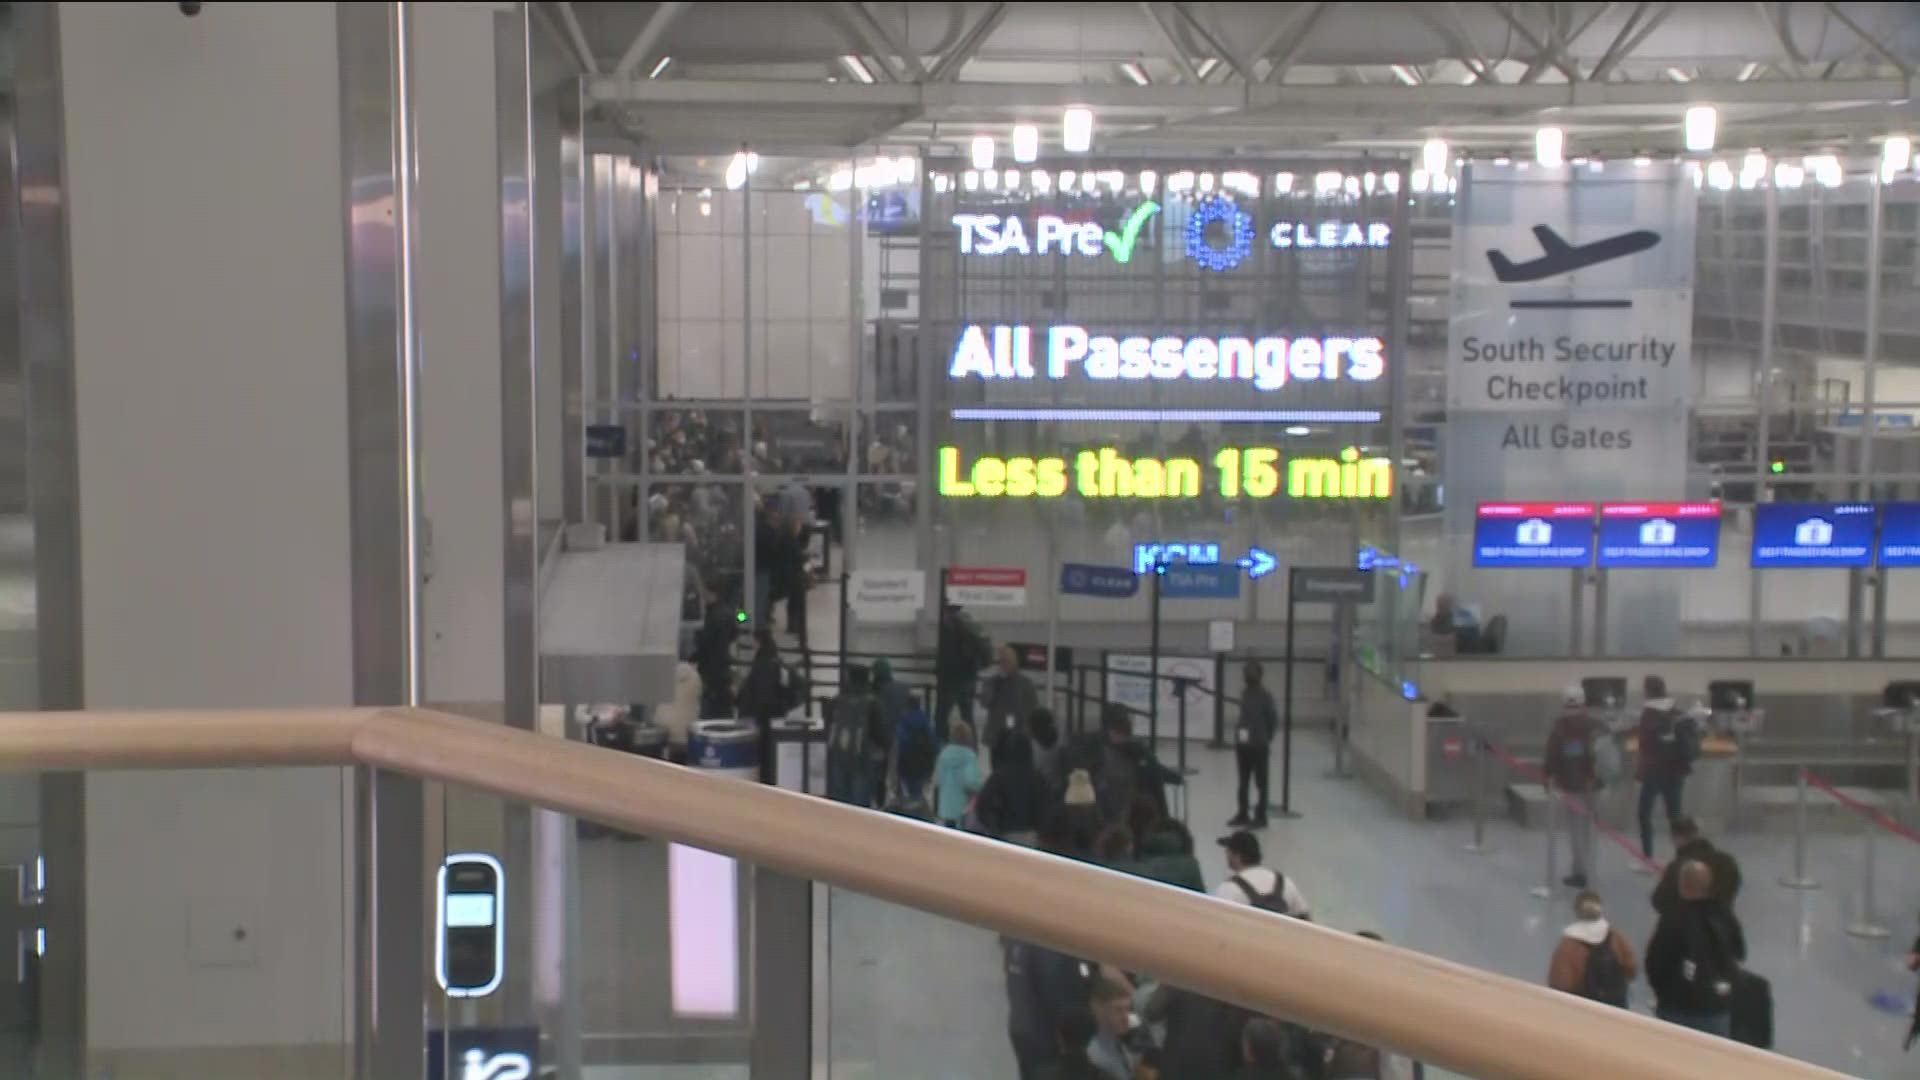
[0,709,1839,1080]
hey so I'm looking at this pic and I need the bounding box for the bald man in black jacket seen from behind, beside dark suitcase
[1645,859,1747,1038]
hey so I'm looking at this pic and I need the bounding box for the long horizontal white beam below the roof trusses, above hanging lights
[588,75,1910,115]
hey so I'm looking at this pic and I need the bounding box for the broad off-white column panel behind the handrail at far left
[60,4,353,1078]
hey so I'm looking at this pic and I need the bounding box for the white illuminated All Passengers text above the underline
[947,325,1386,390]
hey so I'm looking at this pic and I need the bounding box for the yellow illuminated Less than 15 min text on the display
[939,446,1390,499]
